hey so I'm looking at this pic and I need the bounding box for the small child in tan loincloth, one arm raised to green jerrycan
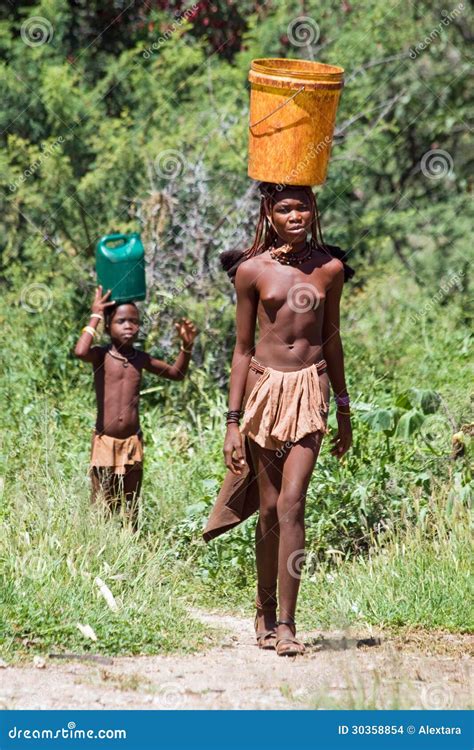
[75,286,198,531]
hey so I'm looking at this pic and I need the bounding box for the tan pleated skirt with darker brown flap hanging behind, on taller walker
[202,357,329,542]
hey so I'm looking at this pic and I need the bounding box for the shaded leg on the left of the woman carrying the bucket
[249,440,284,631]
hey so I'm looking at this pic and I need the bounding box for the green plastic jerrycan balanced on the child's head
[95,232,146,302]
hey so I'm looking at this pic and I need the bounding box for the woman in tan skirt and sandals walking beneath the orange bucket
[204,183,354,656]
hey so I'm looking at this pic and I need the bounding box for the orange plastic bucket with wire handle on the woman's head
[248,58,344,185]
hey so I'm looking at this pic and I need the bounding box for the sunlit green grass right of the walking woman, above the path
[300,496,474,632]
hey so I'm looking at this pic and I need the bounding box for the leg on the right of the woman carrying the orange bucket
[277,432,322,638]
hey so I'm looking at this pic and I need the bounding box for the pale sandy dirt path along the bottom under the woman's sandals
[0,611,474,709]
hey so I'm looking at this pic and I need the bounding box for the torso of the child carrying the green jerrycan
[94,346,148,438]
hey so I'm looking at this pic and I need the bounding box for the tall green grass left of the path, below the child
[0,452,212,657]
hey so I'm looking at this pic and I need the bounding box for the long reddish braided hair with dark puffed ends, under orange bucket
[219,182,354,283]
